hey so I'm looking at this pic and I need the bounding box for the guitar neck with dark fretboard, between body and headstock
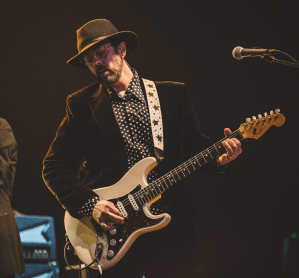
[135,129,244,205]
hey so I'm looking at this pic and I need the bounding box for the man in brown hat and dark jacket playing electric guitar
[43,19,242,278]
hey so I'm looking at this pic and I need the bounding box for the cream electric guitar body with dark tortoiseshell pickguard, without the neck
[64,157,171,270]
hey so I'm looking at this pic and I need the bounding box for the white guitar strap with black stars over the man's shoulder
[142,78,164,162]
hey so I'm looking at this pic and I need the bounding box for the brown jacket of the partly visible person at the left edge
[0,118,25,277]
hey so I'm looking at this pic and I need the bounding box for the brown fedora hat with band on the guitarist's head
[67,19,138,68]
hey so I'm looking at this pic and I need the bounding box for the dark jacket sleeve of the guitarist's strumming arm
[43,96,97,218]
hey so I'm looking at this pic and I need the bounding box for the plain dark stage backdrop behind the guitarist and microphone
[0,0,299,277]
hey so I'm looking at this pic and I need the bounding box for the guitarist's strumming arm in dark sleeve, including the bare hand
[43,97,123,226]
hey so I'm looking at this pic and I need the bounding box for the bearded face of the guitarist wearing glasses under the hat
[83,41,124,86]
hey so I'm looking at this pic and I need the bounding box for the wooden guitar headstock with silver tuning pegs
[239,109,285,139]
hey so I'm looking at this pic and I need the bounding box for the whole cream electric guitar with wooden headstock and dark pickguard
[65,109,285,272]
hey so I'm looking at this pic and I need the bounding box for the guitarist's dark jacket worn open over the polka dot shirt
[43,81,218,217]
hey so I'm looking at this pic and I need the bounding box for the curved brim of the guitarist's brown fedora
[67,31,139,68]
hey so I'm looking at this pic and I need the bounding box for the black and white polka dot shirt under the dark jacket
[79,71,162,216]
